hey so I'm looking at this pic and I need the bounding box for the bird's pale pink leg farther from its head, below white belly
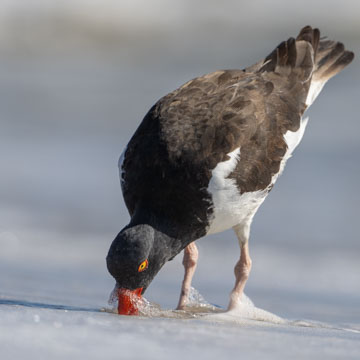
[228,224,251,310]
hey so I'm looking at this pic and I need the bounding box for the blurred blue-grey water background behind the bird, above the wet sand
[0,0,360,324]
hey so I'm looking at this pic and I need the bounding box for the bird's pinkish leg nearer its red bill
[176,242,199,310]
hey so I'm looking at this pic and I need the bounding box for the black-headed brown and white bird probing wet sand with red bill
[106,26,354,315]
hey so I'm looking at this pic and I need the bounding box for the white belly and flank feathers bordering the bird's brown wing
[207,118,309,234]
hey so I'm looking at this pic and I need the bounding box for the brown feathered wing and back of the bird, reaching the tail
[157,31,318,192]
